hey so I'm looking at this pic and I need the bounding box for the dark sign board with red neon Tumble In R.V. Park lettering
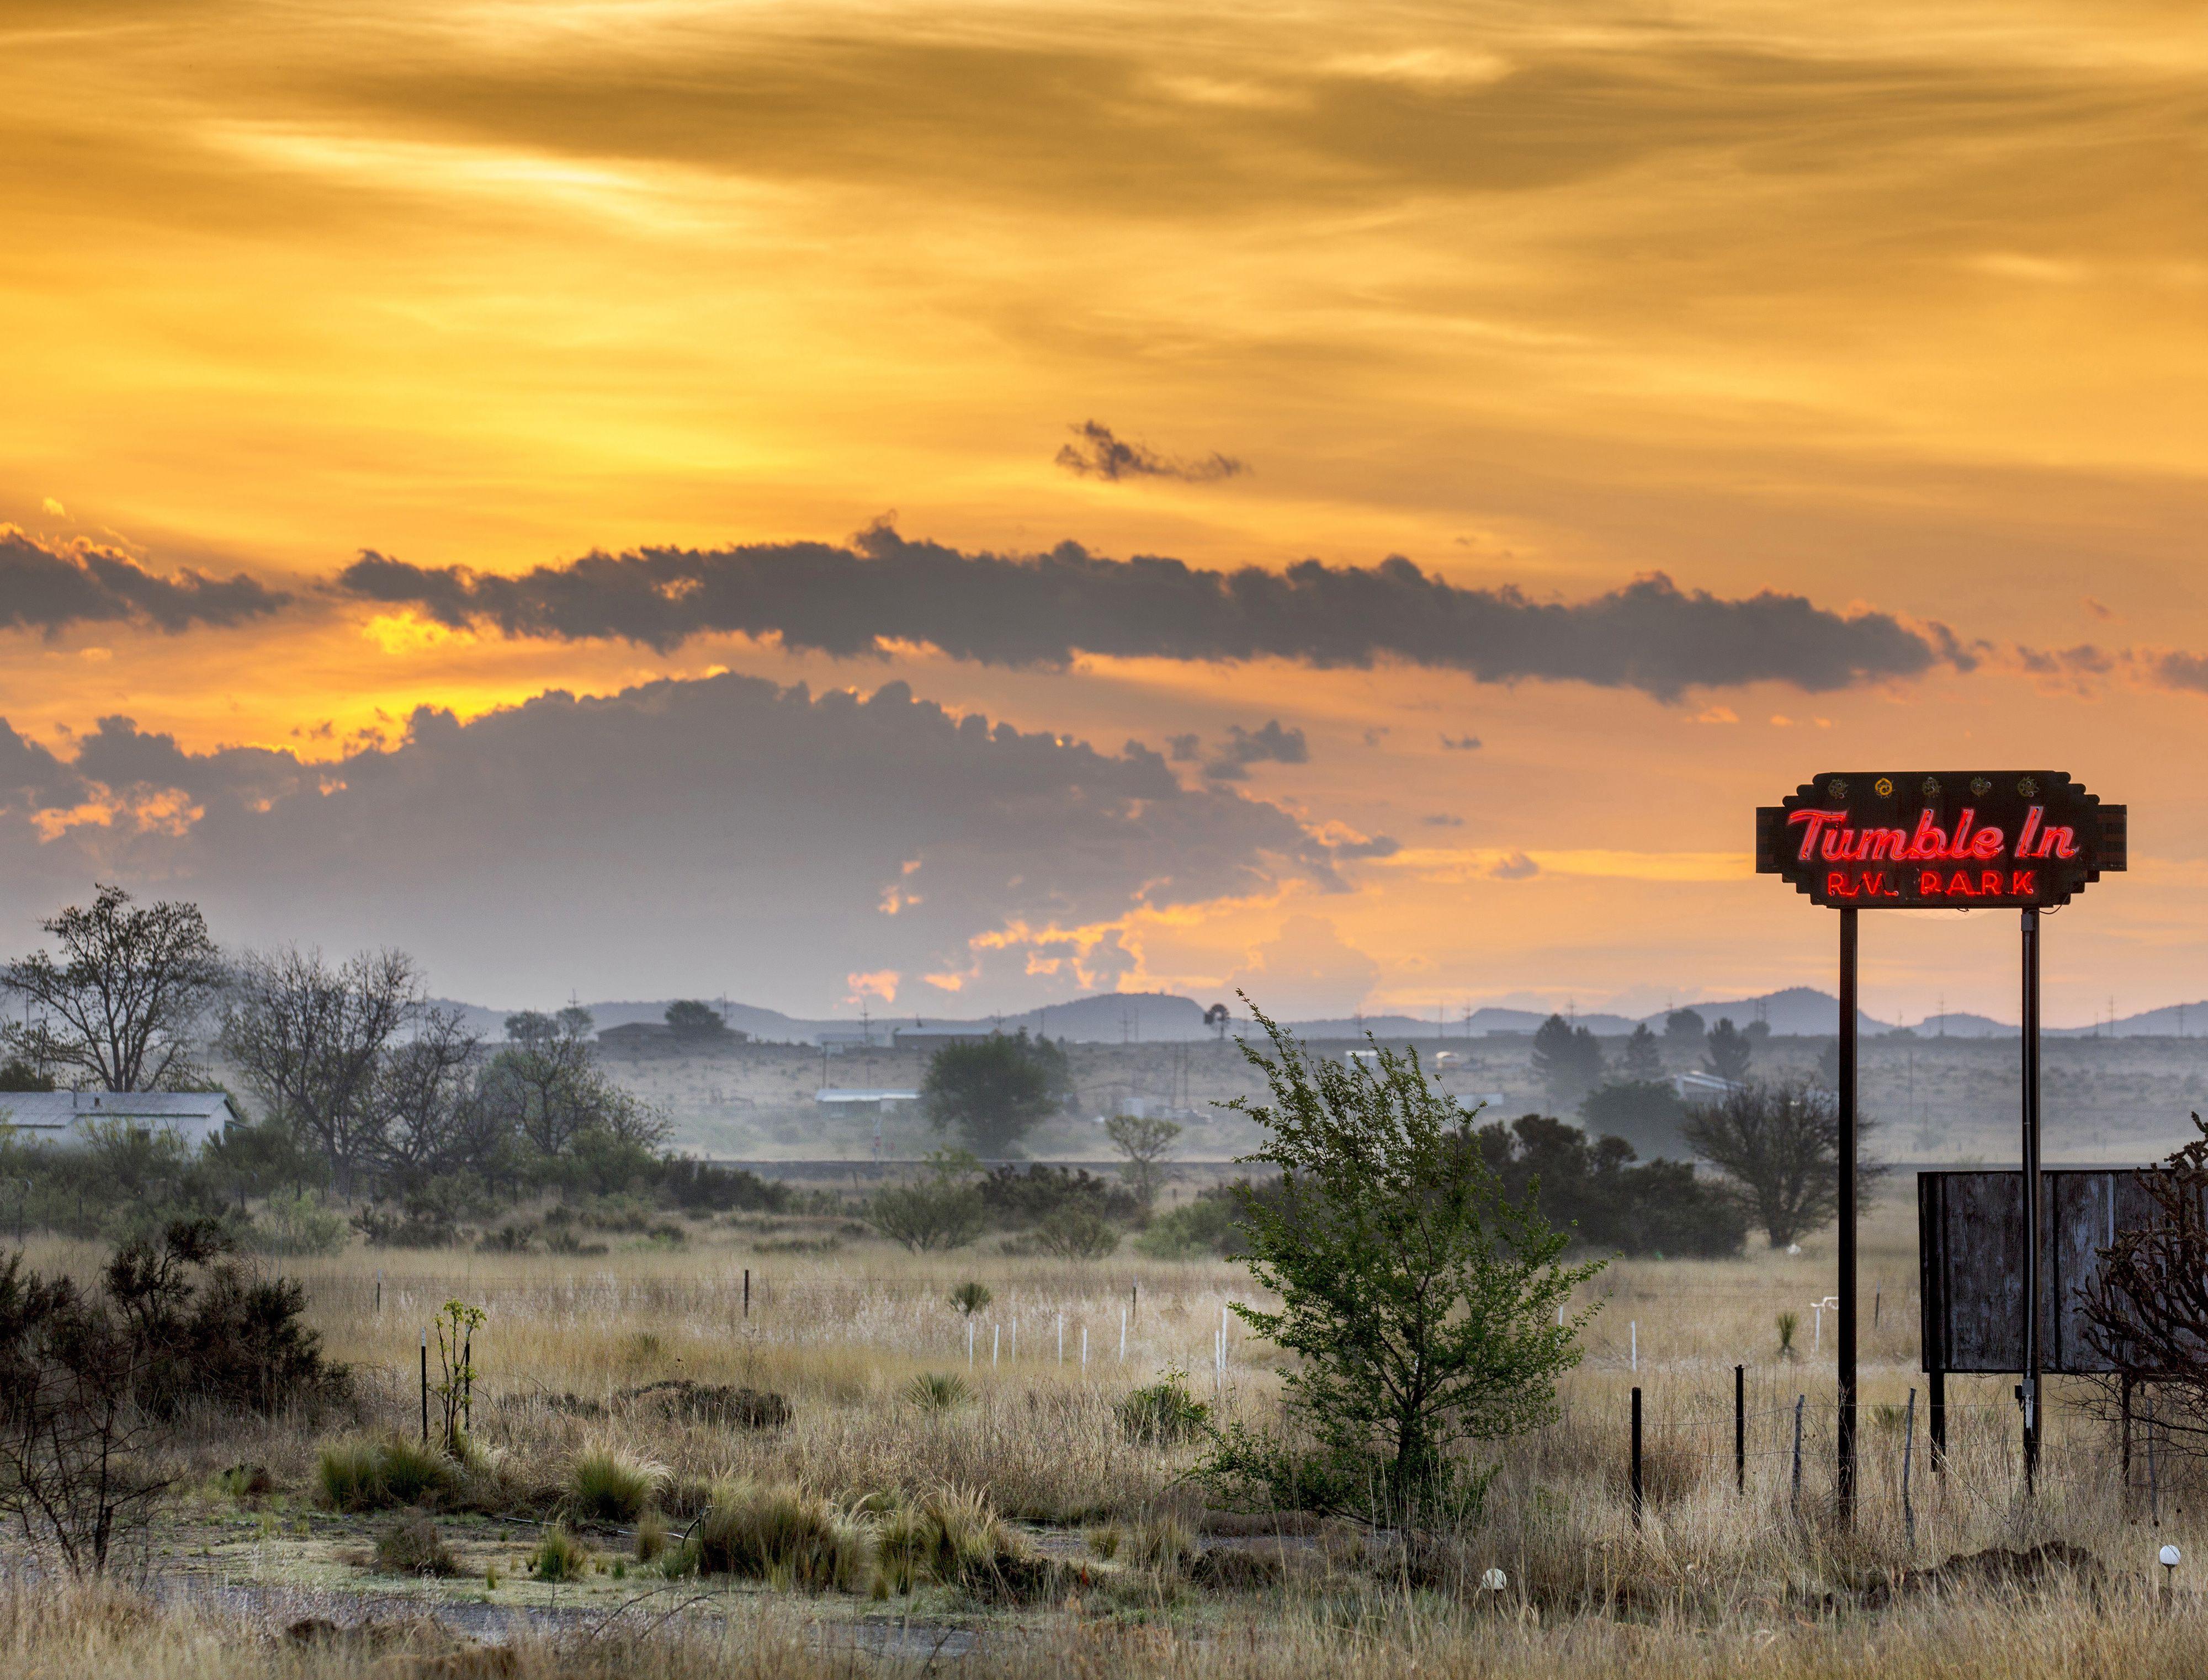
[1755,770,2126,910]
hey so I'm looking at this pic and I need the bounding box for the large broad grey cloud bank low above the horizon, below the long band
[0,676,1393,1007]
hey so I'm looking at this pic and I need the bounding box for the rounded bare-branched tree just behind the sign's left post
[1680,1080,1886,1247]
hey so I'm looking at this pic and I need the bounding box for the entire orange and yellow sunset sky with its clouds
[0,0,2208,1024]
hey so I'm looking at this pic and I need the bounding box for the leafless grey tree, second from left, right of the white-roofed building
[221,947,422,1197]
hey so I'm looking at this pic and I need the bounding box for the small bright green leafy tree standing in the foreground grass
[1208,1011,1603,1521]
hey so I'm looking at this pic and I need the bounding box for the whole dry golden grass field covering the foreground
[0,1197,2208,1680]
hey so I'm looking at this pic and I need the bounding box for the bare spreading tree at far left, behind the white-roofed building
[0,887,225,1091]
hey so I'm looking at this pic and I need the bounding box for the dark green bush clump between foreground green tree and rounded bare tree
[1477,1115,1749,1256]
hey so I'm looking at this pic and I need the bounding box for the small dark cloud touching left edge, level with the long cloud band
[0,525,289,636]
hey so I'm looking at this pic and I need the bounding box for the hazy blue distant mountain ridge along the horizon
[435,987,2208,1044]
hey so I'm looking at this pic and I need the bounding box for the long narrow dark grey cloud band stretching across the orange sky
[338,528,1972,700]
